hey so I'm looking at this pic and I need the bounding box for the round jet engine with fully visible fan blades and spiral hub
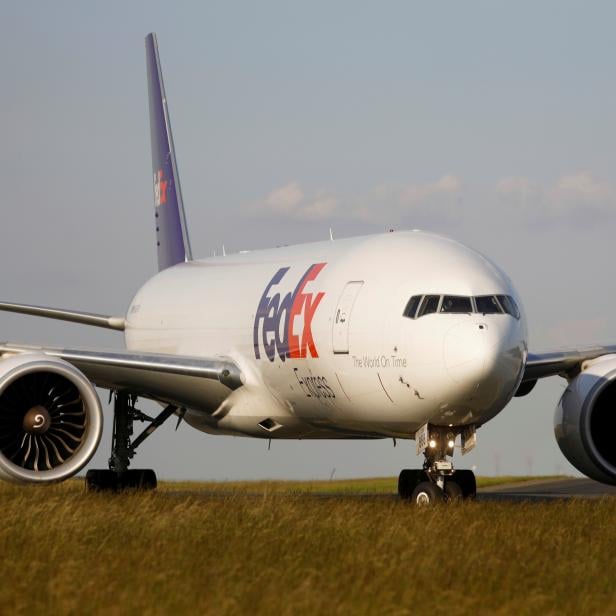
[0,353,103,483]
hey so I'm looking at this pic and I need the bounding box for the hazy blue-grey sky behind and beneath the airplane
[0,1,616,478]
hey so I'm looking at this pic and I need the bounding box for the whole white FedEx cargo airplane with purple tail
[0,34,616,504]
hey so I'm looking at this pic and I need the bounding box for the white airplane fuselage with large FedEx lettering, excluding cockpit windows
[126,231,527,438]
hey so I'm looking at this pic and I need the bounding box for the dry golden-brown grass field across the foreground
[0,479,616,616]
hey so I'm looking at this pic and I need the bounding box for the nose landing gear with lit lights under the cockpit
[398,425,477,505]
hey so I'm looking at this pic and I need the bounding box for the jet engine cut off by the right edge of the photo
[554,355,616,485]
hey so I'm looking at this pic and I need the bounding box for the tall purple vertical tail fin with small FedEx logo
[145,33,192,271]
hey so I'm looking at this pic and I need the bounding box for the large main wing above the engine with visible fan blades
[0,343,243,411]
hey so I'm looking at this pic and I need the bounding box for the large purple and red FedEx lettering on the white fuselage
[253,263,327,361]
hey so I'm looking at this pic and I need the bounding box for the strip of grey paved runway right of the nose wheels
[477,478,616,501]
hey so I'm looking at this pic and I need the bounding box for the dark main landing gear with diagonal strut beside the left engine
[86,391,179,491]
